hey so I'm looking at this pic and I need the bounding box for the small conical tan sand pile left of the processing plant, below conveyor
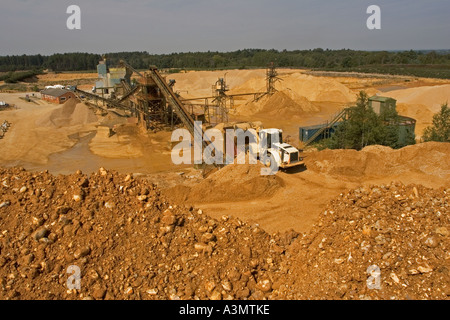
[36,99,98,128]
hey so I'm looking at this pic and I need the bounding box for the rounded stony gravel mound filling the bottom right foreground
[278,183,450,300]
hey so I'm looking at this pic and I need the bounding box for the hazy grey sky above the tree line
[0,0,450,55]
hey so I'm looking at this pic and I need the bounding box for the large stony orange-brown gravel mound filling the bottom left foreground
[0,169,296,300]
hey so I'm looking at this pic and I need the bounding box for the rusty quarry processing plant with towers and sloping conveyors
[74,57,279,130]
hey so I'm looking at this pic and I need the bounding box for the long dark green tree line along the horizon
[0,48,450,78]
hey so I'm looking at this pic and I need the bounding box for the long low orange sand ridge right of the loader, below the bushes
[305,142,450,183]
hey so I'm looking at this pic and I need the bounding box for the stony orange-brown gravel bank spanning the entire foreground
[0,166,450,300]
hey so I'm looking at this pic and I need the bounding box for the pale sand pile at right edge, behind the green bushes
[383,84,450,112]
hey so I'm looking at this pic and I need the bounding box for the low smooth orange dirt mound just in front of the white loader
[167,162,284,203]
